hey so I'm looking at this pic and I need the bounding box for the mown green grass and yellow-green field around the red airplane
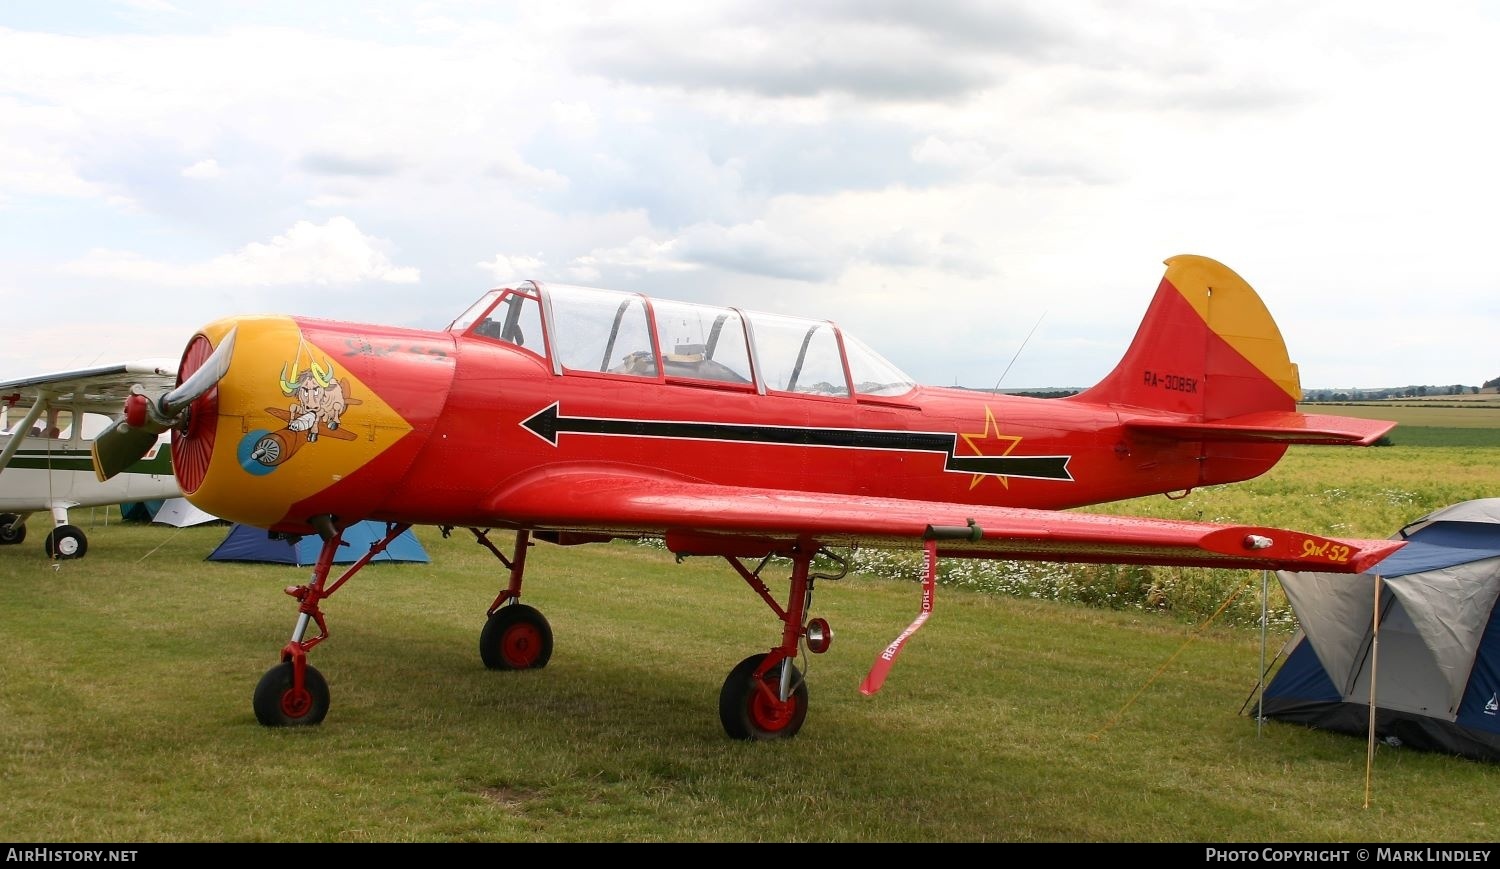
[0,408,1500,843]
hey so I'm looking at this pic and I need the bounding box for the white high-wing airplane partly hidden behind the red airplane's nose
[0,359,182,558]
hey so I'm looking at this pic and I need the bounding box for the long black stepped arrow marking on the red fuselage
[521,402,1073,482]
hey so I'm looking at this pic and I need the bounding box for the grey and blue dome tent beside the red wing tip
[1262,498,1500,762]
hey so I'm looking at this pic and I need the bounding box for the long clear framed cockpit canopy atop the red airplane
[449,281,915,398]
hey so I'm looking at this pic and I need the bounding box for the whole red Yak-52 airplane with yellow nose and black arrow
[93,255,1401,740]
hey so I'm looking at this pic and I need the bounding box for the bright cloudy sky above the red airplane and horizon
[0,0,1500,389]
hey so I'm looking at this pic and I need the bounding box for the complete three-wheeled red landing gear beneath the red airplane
[254,522,849,740]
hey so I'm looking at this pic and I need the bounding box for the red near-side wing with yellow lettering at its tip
[489,467,1404,573]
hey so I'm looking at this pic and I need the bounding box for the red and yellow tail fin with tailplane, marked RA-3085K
[1067,255,1395,444]
